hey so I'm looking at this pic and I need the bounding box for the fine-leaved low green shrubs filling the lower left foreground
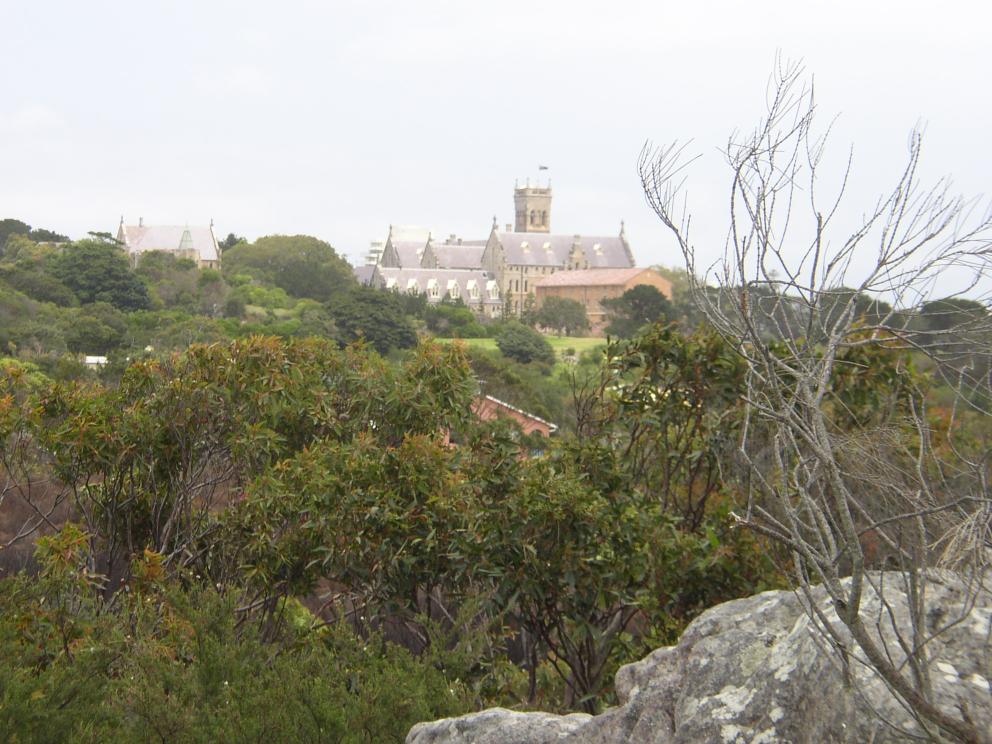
[0,527,472,744]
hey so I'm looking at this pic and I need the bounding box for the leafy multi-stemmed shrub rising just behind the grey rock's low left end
[464,437,652,712]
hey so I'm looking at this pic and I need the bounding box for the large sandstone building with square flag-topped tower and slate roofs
[362,183,634,317]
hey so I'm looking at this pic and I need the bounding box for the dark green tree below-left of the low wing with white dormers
[327,285,417,354]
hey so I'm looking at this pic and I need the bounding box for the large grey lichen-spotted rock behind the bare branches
[407,573,992,744]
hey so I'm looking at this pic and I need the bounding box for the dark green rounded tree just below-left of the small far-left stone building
[51,240,149,311]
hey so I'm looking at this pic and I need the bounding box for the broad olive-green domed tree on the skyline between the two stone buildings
[224,235,355,302]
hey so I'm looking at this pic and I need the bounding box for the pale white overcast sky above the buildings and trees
[0,0,992,274]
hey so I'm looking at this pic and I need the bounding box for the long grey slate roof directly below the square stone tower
[496,232,633,268]
